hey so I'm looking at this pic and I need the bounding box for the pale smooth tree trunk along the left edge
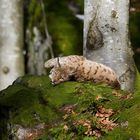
[0,0,24,90]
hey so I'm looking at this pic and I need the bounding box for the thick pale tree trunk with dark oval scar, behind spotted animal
[84,0,135,91]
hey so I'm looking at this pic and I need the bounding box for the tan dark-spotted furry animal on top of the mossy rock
[45,55,120,88]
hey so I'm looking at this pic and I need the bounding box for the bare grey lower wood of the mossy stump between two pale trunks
[26,27,52,75]
